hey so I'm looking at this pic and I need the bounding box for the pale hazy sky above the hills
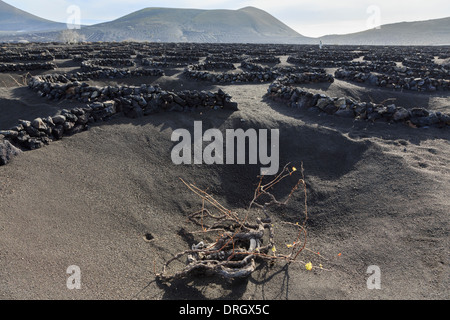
[4,0,450,37]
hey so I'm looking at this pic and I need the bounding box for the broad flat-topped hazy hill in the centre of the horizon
[82,7,311,43]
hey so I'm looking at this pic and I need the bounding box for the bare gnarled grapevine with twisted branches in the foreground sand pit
[156,164,308,281]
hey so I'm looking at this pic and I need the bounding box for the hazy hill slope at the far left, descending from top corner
[0,0,66,34]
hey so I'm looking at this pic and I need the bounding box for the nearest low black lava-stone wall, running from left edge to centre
[0,84,238,165]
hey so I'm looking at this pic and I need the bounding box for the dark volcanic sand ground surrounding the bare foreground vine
[0,65,450,300]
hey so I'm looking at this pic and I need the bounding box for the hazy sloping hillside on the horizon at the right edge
[321,17,450,45]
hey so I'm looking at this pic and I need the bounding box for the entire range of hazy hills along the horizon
[0,0,450,45]
